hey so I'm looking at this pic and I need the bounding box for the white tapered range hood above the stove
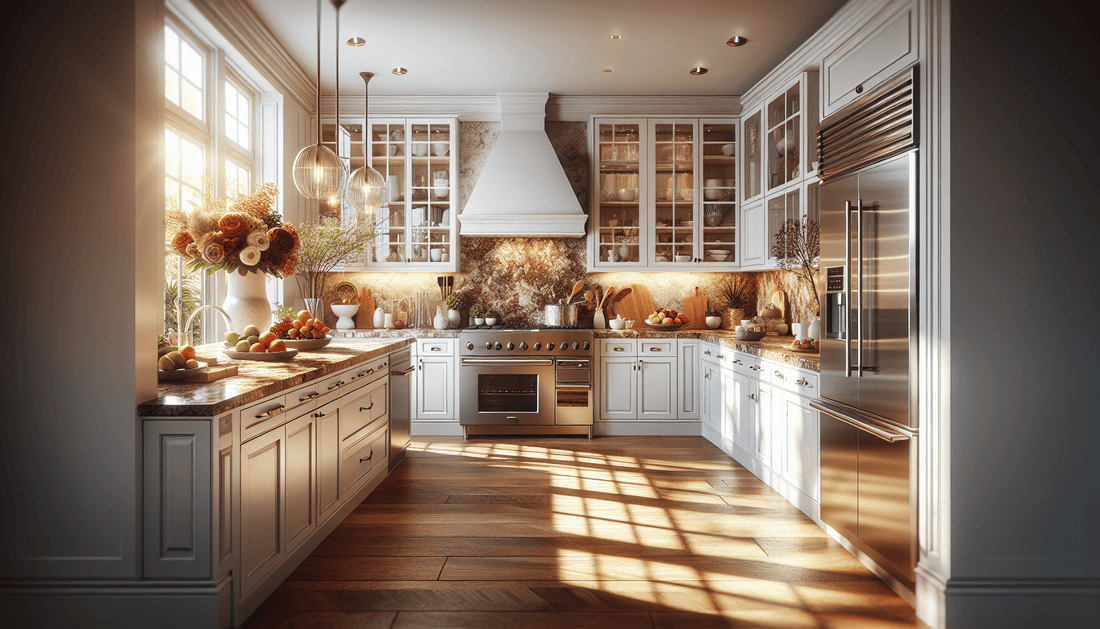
[459,92,589,236]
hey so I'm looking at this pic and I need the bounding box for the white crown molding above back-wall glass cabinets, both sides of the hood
[321,95,741,122]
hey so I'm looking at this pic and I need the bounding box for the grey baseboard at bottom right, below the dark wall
[935,578,1100,629]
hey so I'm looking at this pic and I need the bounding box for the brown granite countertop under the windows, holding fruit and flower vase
[138,338,414,417]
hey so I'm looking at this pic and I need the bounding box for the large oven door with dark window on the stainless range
[459,357,554,426]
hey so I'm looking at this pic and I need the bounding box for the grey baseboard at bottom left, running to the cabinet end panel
[0,581,219,629]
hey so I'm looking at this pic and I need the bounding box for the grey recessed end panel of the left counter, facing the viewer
[142,421,212,578]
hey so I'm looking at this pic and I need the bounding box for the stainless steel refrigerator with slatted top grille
[813,68,920,591]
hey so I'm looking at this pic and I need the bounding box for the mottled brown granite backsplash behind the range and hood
[323,122,815,327]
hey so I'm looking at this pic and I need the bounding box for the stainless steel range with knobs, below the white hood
[459,328,594,439]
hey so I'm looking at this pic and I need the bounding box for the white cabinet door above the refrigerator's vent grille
[821,0,919,118]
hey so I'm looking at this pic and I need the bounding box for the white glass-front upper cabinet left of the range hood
[366,119,459,273]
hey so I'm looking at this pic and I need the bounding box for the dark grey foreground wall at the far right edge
[948,0,1100,627]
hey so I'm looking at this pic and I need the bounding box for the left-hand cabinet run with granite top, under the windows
[138,338,414,627]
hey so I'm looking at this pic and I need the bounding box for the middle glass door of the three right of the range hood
[650,123,695,264]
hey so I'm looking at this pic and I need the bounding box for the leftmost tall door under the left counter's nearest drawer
[241,428,286,593]
